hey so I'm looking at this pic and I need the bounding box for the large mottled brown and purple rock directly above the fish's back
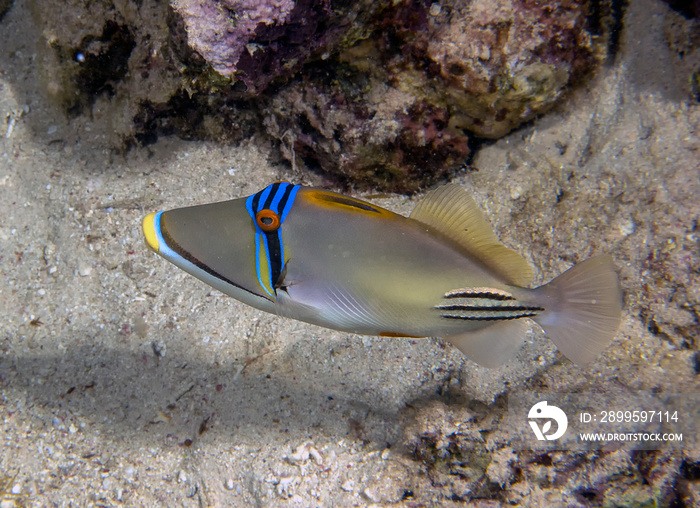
[265,0,597,192]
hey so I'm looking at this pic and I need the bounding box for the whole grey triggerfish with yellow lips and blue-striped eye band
[143,182,622,367]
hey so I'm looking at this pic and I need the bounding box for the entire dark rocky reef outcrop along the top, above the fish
[27,0,621,192]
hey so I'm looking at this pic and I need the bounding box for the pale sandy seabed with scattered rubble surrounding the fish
[0,0,700,508]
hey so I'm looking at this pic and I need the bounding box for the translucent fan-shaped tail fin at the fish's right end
[533,256,622,364]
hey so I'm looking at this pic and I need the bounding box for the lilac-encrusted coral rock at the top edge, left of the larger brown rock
[171,0,382,97]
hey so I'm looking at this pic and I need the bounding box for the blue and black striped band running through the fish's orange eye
[246,182,301,300]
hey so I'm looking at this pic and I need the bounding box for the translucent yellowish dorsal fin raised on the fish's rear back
[411,183,533,286]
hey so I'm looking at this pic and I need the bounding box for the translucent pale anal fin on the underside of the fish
[445,319,527,368]
